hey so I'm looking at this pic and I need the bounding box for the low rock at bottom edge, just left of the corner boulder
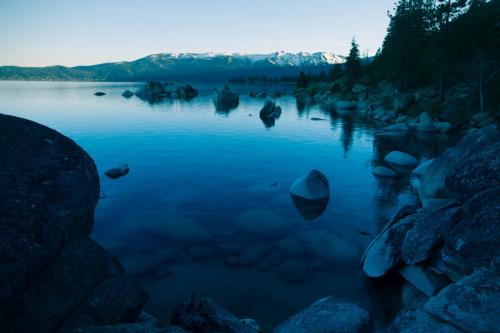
[387,309,463,333]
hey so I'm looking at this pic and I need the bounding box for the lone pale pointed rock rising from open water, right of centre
[290,170,330,201]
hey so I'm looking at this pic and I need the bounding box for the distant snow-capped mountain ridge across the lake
[0,51,345,81]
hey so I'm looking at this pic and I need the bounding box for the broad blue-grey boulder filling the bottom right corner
[425,268,500,332]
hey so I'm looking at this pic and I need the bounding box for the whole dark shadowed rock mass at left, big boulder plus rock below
[0,115,147,333]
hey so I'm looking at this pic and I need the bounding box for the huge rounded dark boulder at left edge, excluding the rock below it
[0,115,99,315]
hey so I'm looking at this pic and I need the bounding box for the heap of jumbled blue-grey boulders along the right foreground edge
[362,126,500,332]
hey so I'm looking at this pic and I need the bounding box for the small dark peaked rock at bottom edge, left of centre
[171,295,255,333]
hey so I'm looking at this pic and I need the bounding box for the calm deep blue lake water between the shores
[0,82,458,332]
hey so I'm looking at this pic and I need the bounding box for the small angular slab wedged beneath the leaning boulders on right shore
[399,266,451,297]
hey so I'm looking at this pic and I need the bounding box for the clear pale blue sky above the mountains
[0,0,394,66]
